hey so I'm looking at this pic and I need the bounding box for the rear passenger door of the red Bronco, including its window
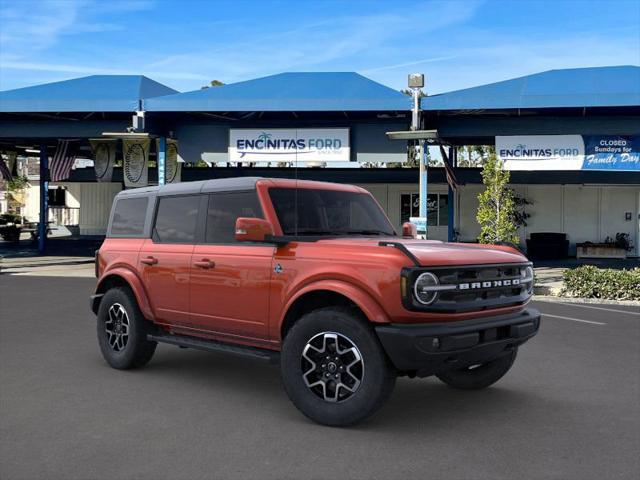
[138,195,202,326]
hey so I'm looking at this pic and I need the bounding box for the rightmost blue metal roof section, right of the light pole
[422,65,640,111]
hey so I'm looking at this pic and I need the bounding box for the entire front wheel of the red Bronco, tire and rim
[281,307,396,426]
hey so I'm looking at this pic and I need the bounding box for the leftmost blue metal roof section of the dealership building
[0,75,177,113]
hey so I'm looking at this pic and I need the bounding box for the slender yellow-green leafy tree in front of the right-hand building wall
[476,154,520,244]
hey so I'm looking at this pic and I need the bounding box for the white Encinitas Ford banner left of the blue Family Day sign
[496,135,584,170]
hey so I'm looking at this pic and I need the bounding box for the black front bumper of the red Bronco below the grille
[375,308,540,377]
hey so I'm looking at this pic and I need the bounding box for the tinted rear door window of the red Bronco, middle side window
[153,195,200,243]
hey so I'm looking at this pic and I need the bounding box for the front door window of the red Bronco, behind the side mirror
[205,191,263,243]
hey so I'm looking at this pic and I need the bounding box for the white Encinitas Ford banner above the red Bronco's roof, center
[229,128,351,162]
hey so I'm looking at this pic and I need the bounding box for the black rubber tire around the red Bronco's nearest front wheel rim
[281,307,397,426]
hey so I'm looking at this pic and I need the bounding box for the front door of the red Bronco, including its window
[191,191,274,340]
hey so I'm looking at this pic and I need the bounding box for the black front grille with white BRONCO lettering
[403,263,533,312]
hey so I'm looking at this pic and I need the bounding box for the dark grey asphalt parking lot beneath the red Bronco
[0,275,640,480]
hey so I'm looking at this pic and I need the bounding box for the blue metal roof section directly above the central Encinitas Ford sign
[144,72,411,112]
